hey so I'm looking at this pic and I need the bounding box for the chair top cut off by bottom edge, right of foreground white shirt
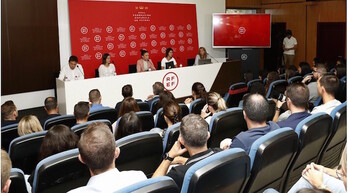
[115,176,180,193]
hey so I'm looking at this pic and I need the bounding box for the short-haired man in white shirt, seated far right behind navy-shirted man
[312,75,341,114]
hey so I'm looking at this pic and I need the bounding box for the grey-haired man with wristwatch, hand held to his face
[152,114,220,189]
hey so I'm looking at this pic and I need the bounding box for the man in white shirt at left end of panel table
[58,56,85,81]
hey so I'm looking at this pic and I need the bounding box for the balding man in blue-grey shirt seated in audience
[220,94,279,154]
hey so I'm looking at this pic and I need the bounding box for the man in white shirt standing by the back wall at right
[283,30,297,67]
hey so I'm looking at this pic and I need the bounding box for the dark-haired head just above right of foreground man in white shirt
[114,111,142,140]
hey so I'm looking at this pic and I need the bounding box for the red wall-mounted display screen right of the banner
[213,14,271,48]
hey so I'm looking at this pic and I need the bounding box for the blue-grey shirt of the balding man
[230,121,279,154]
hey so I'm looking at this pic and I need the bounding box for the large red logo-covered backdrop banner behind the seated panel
[69,0,198,78]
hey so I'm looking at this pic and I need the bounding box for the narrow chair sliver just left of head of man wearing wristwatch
[163,122,181,154]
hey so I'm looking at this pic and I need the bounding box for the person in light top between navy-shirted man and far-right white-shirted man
[302,64,327,103]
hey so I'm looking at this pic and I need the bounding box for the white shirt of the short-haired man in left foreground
[69,168,147,193]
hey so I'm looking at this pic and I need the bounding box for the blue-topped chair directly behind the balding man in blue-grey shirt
[244,127,298,192]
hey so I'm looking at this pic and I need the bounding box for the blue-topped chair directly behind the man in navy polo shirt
[283,112,332,192]
